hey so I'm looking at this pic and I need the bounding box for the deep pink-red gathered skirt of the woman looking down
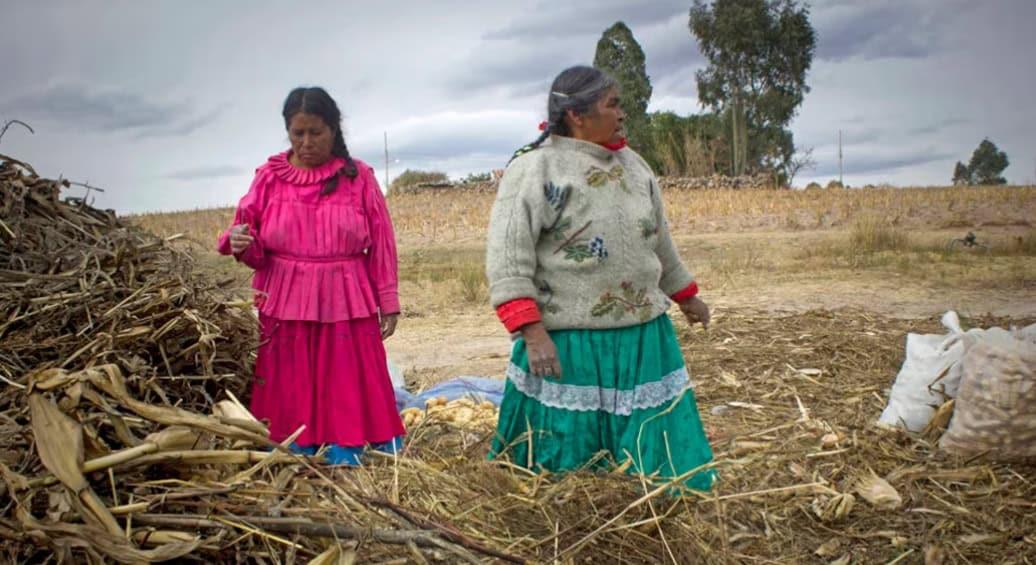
[251,315,404,447]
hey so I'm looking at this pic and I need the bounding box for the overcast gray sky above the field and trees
[0,0,1036,213]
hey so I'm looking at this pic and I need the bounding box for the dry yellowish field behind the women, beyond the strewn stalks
[135,187,1036,385]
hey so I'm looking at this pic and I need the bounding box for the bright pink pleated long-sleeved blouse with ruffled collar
[219,151,399,322]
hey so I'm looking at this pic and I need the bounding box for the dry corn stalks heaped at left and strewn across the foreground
[0,151,1036,563]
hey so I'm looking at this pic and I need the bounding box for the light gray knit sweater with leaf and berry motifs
[486,136,693,330]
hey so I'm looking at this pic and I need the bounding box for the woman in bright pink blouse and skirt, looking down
[219,88,404,464]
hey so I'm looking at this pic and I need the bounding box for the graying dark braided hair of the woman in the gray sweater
[511,65,618,160]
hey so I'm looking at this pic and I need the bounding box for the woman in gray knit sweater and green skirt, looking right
[486,66,715,489]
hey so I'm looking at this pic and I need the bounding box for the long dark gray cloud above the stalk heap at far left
[0,83,219,137]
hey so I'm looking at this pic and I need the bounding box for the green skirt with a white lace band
[489,315,715,490]
